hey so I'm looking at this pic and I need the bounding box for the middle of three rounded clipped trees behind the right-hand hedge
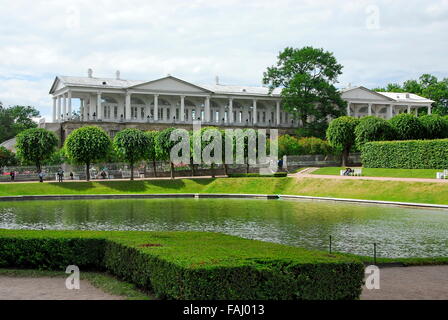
[389,113,425,140]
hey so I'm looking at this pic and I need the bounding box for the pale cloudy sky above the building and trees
[0,0,448,116]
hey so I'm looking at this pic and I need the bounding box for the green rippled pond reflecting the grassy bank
[0,199,448,257]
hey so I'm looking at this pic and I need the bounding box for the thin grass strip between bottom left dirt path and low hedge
[0,269,155,300]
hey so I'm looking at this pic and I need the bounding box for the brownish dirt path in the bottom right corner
[361,266,448,300]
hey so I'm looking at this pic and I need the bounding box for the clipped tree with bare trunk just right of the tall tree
[327,116,359,167]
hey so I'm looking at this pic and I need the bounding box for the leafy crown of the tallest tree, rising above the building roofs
[263,47,346,137]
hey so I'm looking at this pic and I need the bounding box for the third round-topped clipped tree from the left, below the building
[113,128,151,180]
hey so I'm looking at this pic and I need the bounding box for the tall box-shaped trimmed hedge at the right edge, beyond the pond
[361,139,448,169]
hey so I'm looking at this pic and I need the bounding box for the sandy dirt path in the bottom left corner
[0,276,123,300]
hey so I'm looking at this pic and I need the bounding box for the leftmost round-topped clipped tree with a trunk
[16,128,59,172]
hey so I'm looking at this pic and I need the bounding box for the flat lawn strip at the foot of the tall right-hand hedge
[312,167,443,179]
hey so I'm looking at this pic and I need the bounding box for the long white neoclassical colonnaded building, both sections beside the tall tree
[41,69,433,141]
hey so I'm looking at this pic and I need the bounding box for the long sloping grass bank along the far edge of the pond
[0,178,448,204]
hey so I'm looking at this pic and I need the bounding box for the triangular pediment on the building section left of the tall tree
[131,76,210,93]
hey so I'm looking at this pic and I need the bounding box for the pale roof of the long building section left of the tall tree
[50,76,281,96]
